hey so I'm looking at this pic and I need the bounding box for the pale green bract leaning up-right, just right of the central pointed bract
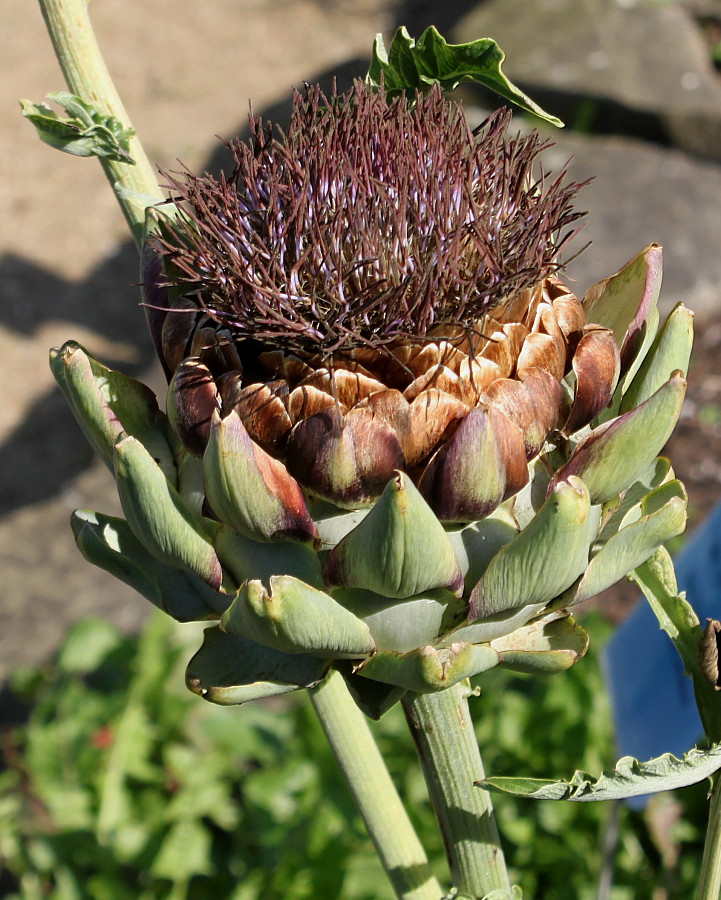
[468,476,598,622]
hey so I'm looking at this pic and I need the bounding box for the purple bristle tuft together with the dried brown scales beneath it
[150,85,619,522]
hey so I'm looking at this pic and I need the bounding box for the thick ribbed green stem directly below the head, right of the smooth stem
[403,684,510,897]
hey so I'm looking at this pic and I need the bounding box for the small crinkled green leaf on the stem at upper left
[20,91,135,166]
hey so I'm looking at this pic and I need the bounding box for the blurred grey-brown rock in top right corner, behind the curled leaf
[452,0,721,159]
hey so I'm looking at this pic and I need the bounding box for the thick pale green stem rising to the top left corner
[40,0,163,245]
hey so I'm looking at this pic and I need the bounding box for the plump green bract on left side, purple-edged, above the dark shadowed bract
[115,437,222,589]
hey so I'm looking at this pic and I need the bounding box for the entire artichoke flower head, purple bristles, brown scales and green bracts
[52,83,692,717]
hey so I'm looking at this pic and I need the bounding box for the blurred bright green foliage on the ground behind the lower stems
[0,615,705,900]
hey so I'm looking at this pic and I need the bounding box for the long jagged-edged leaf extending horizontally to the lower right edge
[478,744,721,801]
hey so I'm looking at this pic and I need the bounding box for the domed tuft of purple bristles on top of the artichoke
[160,82,581,353]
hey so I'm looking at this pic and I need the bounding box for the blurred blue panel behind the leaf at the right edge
[603,504,721,805]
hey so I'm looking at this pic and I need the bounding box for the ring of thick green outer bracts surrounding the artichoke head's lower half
[52,241,691,716]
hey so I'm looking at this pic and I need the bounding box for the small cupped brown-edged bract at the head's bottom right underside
[491,613,588,675]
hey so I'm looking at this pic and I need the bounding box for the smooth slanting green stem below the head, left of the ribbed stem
[310,672,443,900]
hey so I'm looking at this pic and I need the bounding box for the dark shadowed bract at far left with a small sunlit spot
[70,509,231,622]
